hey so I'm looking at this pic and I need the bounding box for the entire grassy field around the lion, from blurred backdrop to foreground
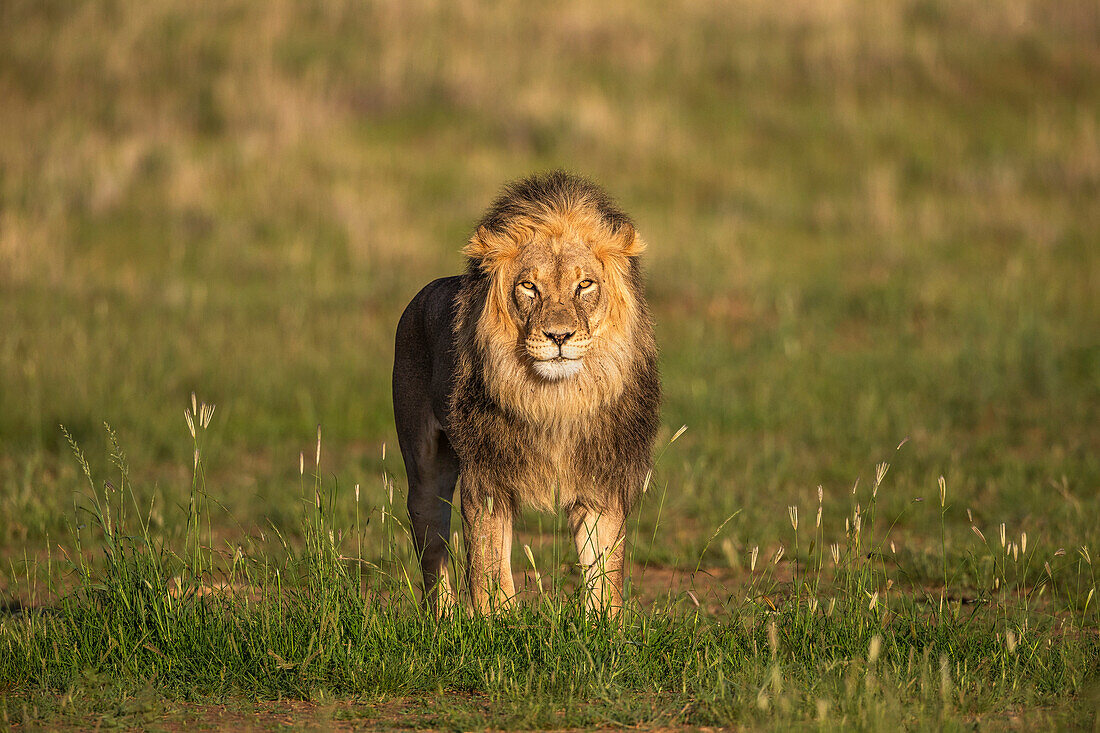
[0,0,1100,730]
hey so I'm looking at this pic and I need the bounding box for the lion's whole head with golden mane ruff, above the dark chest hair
[457,176,655,416]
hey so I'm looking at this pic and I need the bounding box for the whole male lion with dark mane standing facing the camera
[393,172,661,613]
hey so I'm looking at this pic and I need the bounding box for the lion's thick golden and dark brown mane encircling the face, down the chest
[449,172,660,512]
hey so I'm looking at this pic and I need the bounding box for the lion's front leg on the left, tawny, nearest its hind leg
[461,477,516,613]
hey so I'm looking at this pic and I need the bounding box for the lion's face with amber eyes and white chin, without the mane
[509,240,607,381]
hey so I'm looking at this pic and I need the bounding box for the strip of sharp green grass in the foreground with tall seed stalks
[0,424,1100,729]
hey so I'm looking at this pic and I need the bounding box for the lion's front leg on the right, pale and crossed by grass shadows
[569,505,626,615]
